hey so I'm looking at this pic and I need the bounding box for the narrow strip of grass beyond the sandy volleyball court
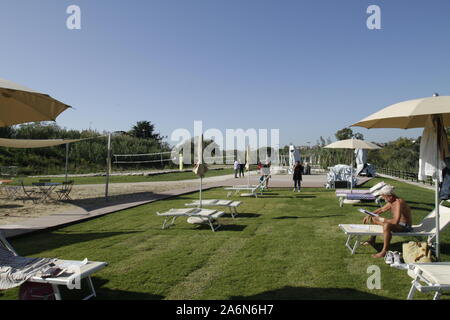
[11,169,234,186]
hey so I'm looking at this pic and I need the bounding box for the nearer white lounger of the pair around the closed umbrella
[156,208,225,232]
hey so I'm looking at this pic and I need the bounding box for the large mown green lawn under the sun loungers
[0,179,450,300]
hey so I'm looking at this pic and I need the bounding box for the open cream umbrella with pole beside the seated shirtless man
[352,94,450,258]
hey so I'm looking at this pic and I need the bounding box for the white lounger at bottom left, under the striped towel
[0,233,108,300]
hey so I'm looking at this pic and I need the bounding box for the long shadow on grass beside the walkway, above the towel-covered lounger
[11,231,141,256]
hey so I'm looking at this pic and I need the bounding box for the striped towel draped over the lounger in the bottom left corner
[0,246,57,290]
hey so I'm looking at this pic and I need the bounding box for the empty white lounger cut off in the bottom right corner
[407,262,450,300]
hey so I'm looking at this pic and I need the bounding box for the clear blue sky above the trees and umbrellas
[0,0,450,144]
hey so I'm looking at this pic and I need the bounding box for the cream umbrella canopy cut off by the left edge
[0,79,70,127]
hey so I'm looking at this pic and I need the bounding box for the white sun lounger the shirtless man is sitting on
[339,206,450,254]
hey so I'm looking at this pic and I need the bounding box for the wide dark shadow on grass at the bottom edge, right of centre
[231,287,387,300]
